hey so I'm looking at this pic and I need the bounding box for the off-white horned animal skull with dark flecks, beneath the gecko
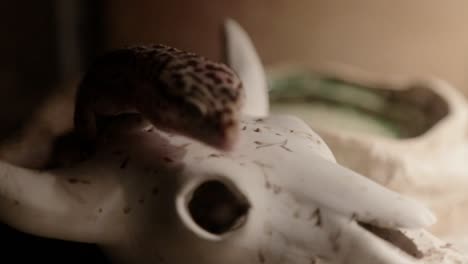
[0,19,461,264]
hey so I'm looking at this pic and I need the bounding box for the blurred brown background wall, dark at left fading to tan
[0,0,468,263]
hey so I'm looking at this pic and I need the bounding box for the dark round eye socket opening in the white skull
[187,180,250,235]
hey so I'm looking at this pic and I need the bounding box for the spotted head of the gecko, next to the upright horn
[146,52,244,150]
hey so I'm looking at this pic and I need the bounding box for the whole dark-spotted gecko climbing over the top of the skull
[74,44,244,150]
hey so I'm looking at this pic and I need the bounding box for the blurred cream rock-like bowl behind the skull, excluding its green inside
[270,64,468,250]
